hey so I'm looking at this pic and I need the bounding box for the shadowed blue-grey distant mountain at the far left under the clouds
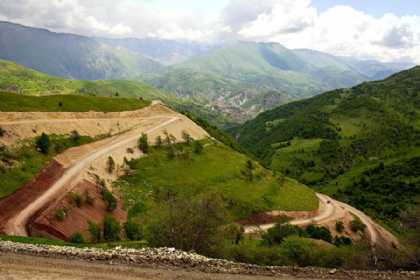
[0,22,162,80]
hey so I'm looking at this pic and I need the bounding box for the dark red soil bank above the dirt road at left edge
[0,160,65,233]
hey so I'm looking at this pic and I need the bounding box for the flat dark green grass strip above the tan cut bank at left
[0,93,150,112]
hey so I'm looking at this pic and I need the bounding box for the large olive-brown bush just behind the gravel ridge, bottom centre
[147,195,226,255]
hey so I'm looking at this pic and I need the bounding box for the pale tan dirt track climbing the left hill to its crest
[0,104,207,236]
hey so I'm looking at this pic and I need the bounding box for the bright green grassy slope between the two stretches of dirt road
[118,143,318,222]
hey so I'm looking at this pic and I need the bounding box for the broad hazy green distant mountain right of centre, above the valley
[148,42,410,117]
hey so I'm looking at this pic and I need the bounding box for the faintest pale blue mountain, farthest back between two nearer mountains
[98,38,218,65]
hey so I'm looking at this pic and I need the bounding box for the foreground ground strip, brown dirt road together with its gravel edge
[0,242,420,280]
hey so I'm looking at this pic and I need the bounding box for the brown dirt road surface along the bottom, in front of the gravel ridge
[0,254,308,280]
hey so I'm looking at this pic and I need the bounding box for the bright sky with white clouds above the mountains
[0,0,420,64]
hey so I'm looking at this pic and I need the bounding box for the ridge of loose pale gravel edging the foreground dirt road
[0,241,420,280]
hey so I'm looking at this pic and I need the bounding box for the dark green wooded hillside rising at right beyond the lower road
[236,67,420,231]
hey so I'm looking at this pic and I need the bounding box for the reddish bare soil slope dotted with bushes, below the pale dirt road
[28,180,127,240]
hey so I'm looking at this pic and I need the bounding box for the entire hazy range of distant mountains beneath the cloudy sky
[0,19,414,121]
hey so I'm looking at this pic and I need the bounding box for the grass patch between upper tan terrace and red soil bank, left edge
[0,135,95,198]
